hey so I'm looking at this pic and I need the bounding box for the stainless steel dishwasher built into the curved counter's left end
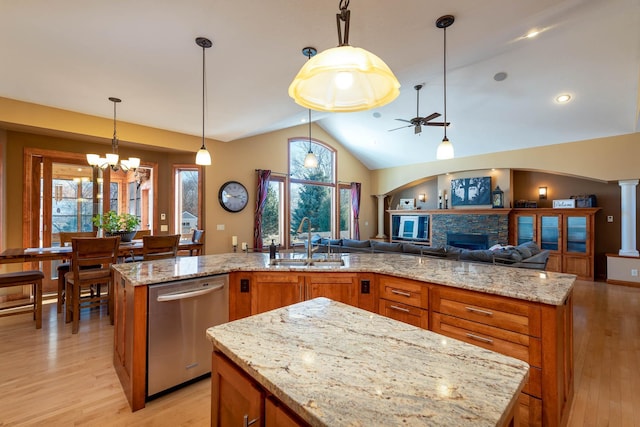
[147,274,229,398]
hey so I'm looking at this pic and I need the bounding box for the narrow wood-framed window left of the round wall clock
[173,165,204,239]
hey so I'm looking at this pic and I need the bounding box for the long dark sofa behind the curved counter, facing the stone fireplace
[311,236,549,270]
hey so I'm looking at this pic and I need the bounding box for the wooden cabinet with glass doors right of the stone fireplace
[509,208,599,280]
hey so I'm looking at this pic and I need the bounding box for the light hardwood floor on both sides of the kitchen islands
[0,281,640,427]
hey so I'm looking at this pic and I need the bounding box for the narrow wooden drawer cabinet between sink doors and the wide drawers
[378,276,429,329]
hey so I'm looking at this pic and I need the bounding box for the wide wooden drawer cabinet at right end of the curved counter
[430,286,573,426]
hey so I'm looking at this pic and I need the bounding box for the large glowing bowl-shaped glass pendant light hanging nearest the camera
[289,0,400,112]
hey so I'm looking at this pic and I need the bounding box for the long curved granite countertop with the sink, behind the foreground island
[113,253,576,305]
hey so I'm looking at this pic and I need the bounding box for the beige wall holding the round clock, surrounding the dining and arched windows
[0,98,376,253]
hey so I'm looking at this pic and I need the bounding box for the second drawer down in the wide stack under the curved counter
[431,313,542,367]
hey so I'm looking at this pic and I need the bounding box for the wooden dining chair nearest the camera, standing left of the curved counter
[65,236,120,334]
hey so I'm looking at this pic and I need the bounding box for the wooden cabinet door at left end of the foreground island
[211,352,264,427]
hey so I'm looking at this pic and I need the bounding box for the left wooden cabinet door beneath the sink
[251,272,304,314]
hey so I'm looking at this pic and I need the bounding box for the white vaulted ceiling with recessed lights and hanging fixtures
[0,0,640,169]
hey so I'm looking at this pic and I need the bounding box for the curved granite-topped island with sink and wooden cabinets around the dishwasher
[113,253,575,426]
